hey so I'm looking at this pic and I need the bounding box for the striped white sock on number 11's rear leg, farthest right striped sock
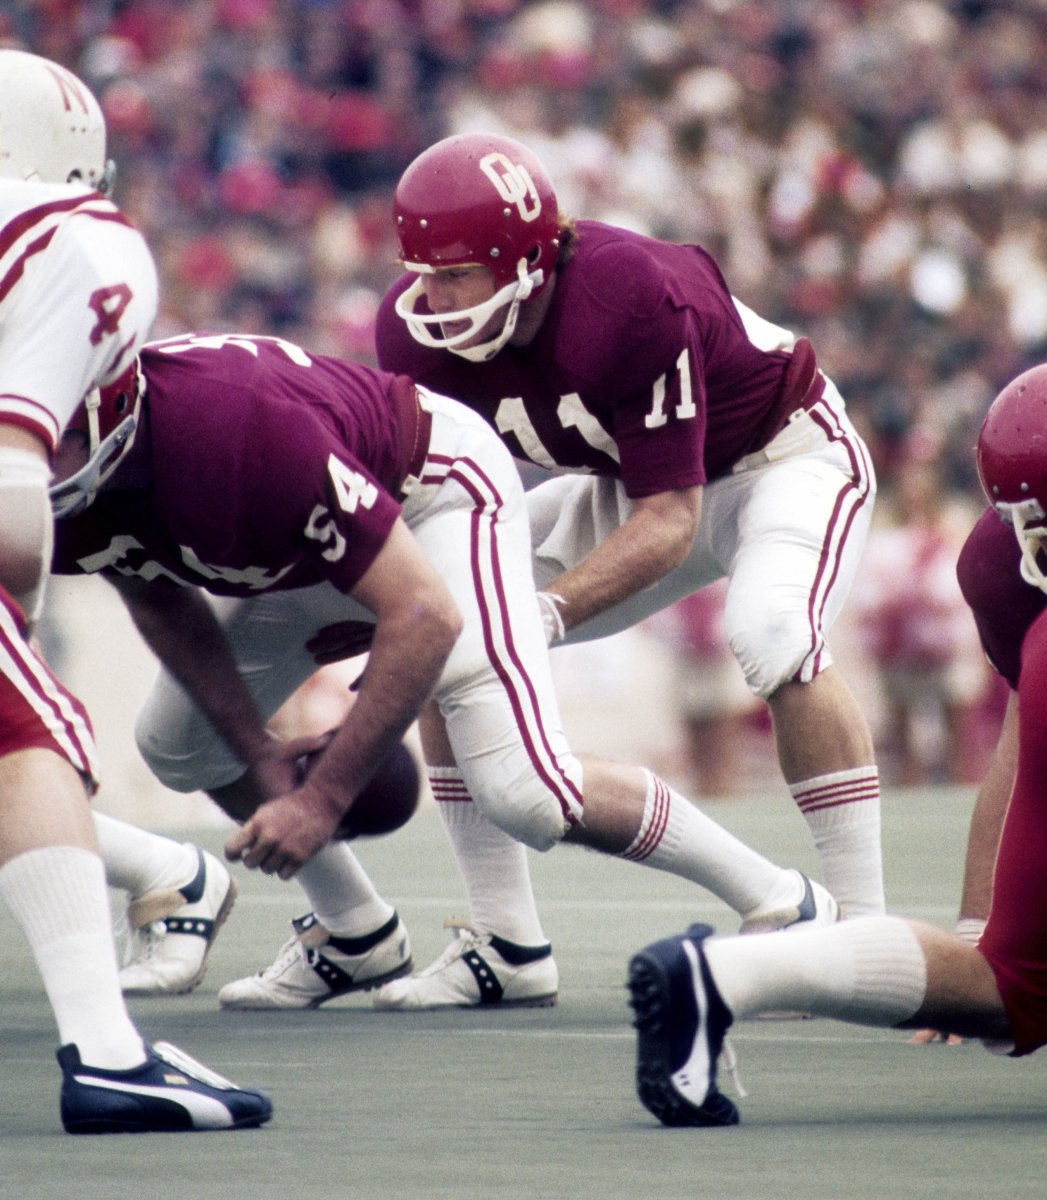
[789,767,885,918]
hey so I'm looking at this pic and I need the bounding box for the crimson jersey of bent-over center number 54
[54,335,414,596]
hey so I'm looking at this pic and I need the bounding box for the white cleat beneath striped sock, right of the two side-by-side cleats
[373,920,560,1012]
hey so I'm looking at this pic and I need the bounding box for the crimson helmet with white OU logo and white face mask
[393,133,560,362]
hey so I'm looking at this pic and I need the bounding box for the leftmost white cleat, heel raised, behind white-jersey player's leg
[120,850,237,996]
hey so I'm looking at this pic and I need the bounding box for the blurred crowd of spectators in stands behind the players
[12,0,1047,796]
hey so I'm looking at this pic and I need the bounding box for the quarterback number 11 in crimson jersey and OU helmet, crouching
[376,133,884,1008]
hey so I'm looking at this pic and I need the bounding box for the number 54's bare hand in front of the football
[226,787,341,880]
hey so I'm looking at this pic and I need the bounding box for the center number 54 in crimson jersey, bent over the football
[54,335,837,1008]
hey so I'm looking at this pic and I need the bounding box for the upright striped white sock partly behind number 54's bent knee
[429,767,548,946]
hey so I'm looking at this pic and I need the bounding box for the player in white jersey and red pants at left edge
[0,49,271,1133]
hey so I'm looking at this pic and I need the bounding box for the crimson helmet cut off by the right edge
[977,366,1047,592]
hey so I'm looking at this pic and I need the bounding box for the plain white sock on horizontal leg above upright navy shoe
[705,917,927,1025]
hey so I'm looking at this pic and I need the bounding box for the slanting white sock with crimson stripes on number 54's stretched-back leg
[620,770,803,919]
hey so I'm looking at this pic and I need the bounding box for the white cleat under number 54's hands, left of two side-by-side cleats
[219,912,414,1009]
